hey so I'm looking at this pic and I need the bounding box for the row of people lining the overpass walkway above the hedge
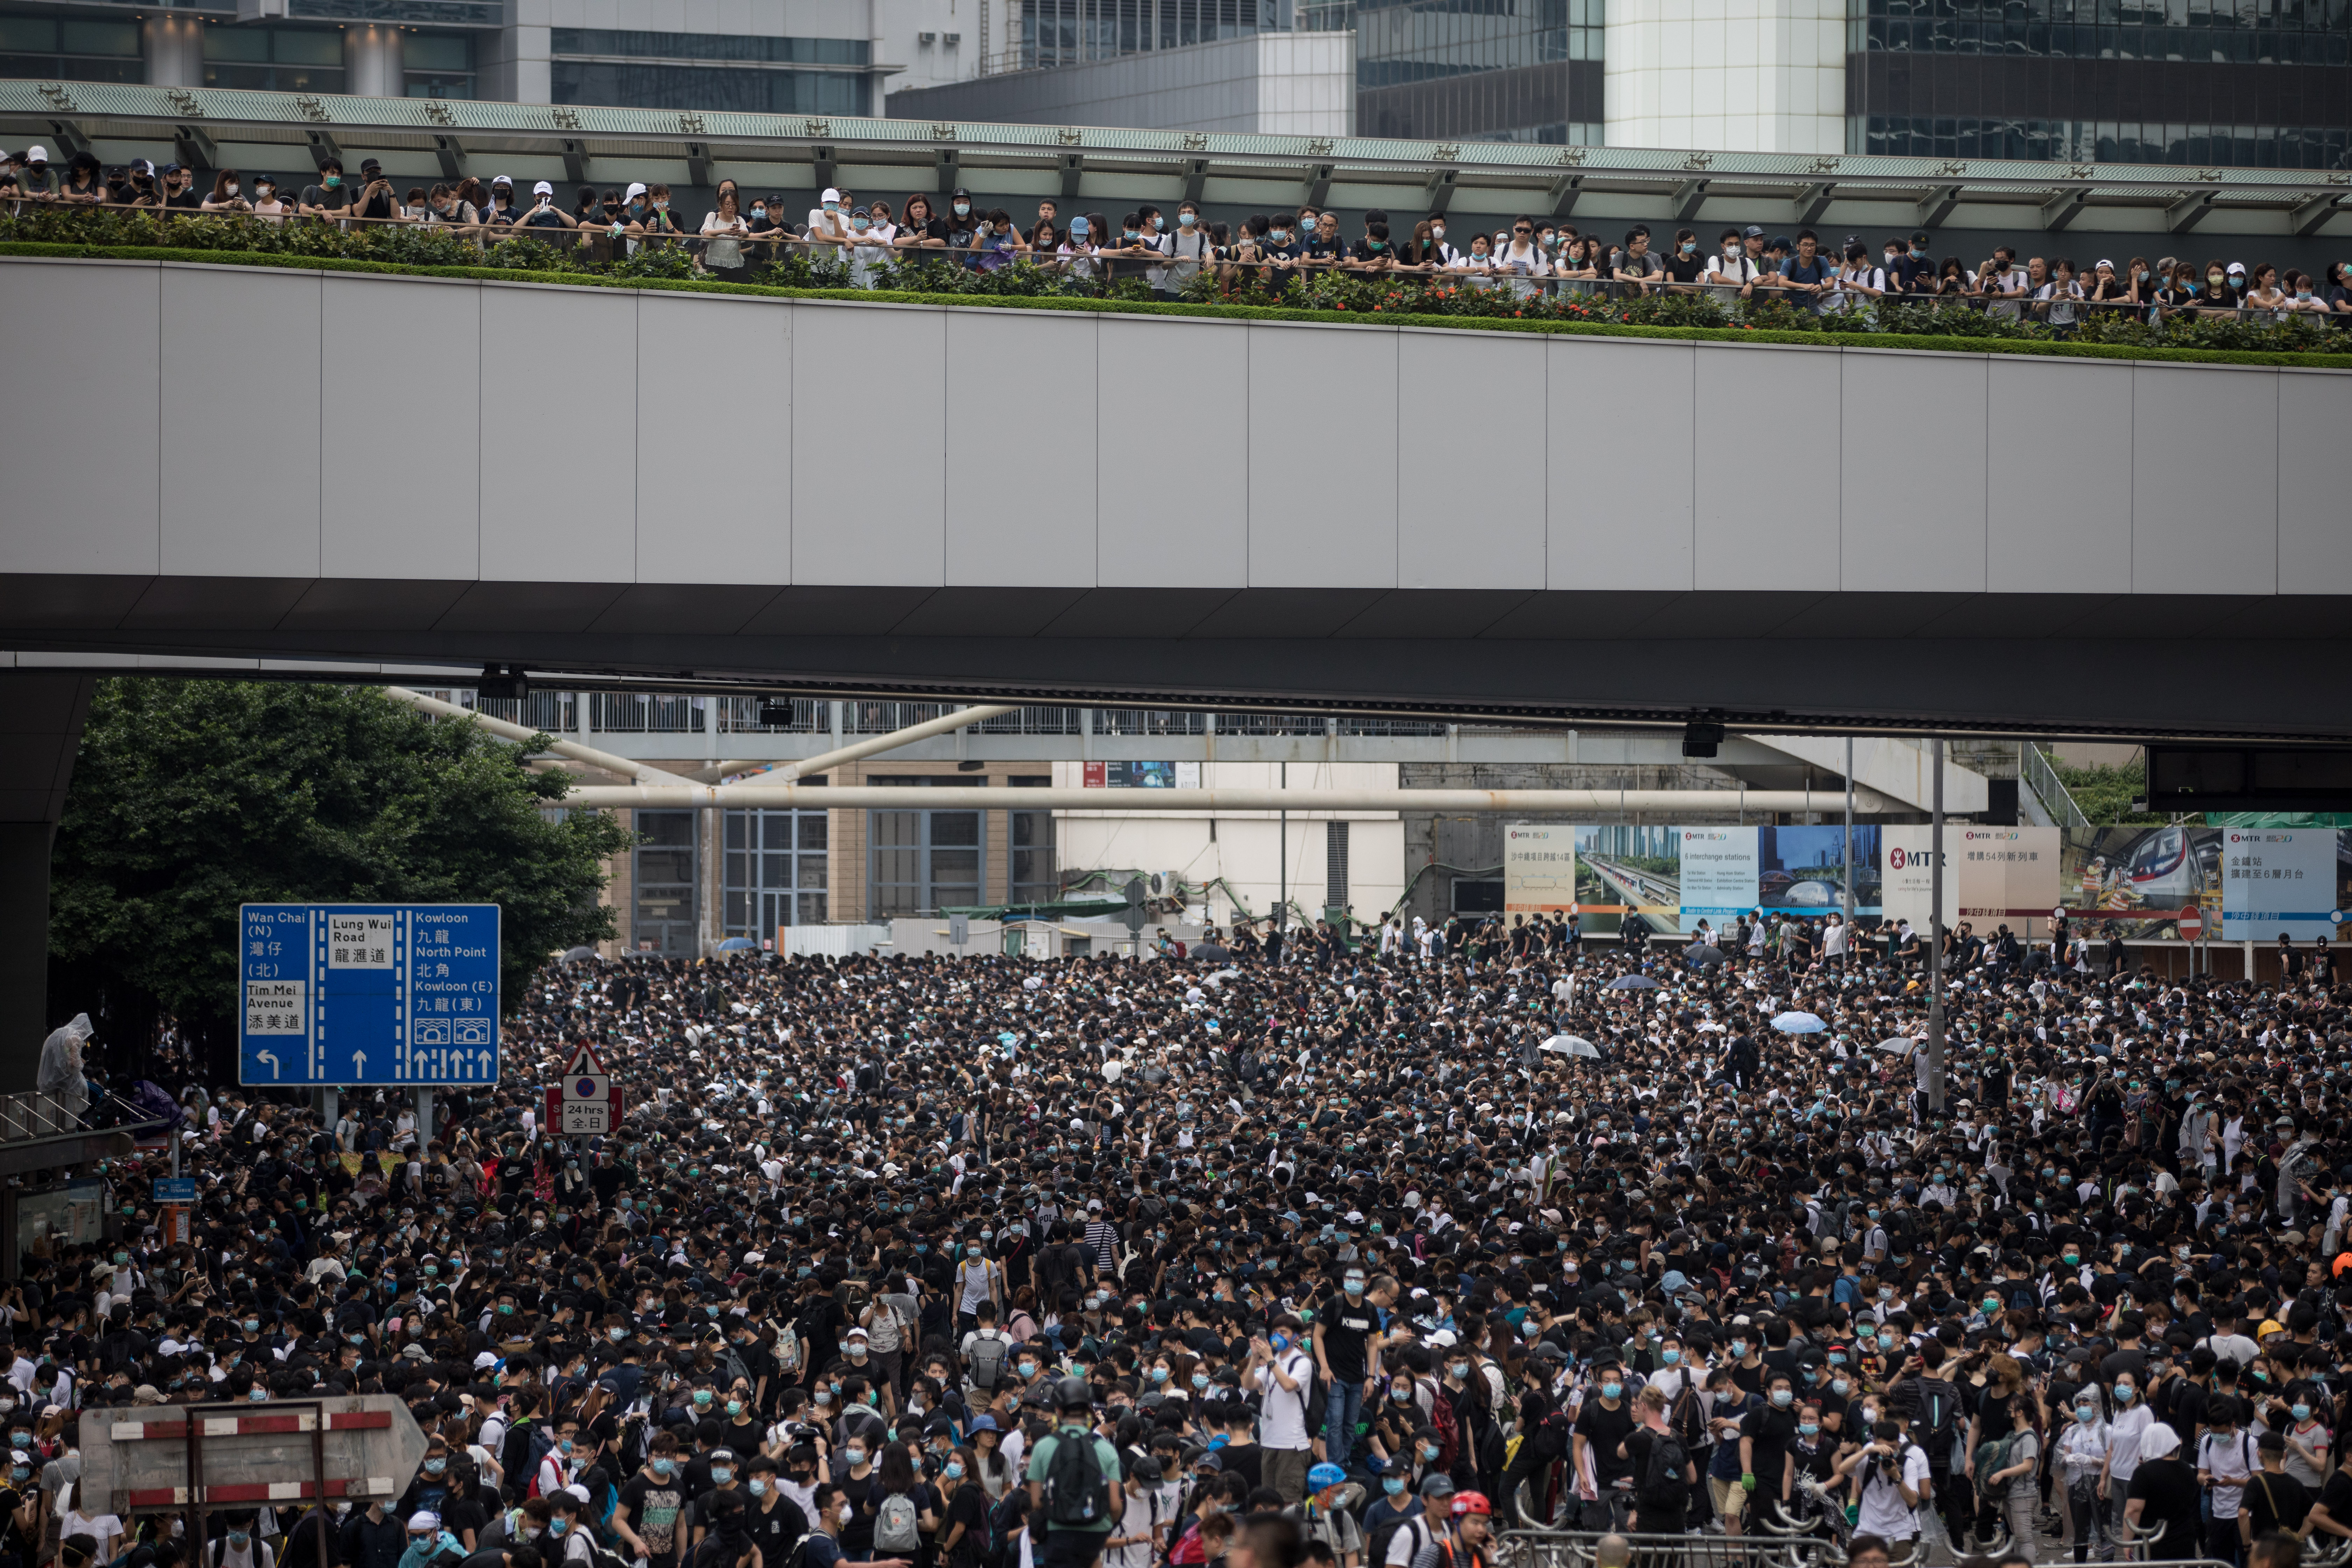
[0,146,2352,334]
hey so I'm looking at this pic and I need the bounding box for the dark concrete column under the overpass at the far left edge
[0,675,97,1093]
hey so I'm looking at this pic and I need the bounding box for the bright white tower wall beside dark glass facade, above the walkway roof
[1606,0,1846,153]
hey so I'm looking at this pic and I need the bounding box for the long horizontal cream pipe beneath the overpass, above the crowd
[562,783,1898,816]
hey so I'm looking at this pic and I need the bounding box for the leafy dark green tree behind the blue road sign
[49,679,633,1063]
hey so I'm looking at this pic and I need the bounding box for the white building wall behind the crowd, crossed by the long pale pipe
[1054,762,1404,924]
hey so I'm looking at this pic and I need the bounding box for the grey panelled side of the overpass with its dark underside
[0,259,2352,738]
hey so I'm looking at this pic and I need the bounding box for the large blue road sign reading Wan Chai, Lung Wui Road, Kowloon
[238,903,499,1088]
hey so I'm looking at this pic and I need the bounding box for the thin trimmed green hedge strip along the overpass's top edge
[14,240,2352,369]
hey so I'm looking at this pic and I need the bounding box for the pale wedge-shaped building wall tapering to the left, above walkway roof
[889,33,1355,136]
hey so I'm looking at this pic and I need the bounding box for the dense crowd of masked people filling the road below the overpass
[18,922,2352,1568]
